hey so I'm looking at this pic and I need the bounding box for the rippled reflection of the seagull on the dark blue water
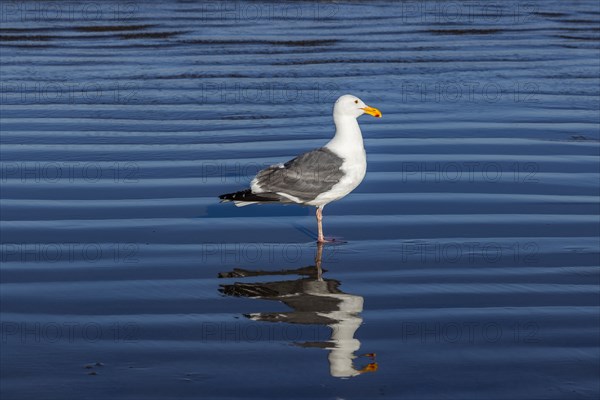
[219,244,377,378]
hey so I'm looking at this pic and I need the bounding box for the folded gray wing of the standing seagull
[252,147,344,202]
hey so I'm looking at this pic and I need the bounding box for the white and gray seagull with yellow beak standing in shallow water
[219,94,381,243]
